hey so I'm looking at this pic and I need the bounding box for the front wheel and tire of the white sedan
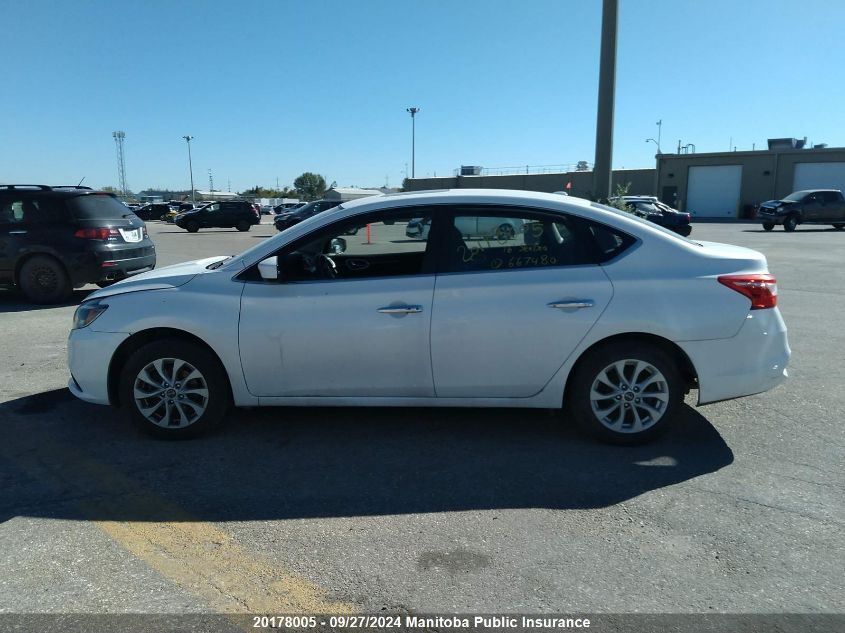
[119,338,231,440]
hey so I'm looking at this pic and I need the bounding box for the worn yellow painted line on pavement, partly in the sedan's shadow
[0,416,355,614]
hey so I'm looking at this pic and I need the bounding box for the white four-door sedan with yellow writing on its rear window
[68,190,790,443]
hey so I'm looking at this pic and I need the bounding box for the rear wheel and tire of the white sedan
[565,341,684,445]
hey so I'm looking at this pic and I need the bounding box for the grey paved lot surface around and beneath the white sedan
[0,220,845,613]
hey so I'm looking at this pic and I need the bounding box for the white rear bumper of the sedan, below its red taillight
[678,308,791,404]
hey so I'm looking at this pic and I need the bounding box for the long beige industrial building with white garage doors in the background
[405,138,845,219]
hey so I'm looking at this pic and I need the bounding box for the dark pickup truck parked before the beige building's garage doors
[757,189,845,231]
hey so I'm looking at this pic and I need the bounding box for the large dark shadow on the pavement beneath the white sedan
[0,389,733,521]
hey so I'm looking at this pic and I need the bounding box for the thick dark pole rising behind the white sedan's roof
[593,0,619,200]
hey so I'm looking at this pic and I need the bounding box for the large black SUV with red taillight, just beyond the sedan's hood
[0,185,156,303]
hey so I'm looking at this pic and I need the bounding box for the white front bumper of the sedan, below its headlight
[67,324,129,404]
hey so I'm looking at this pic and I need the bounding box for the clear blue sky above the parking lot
[0,0,845,191]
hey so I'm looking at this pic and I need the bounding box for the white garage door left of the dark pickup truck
[684,165,742,218]
